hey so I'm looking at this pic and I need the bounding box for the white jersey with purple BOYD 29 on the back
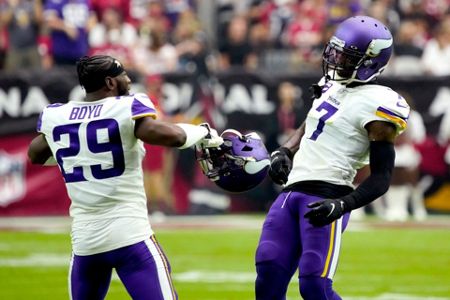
[37,94,156,255]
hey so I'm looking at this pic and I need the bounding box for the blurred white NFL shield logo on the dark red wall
[0,151,26,207]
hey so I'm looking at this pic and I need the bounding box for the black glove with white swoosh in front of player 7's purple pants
[305,199,345,227]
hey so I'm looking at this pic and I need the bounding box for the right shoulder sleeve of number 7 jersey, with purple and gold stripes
[361,87,410,134]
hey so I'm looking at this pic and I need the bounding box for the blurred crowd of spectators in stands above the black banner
[0,0,450,75]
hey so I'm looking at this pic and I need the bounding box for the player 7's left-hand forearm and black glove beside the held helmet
[269,123,305,185]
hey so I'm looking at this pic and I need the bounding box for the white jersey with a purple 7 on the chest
[286,81,409,187]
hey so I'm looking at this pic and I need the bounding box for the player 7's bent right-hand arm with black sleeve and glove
[305,121,397,226]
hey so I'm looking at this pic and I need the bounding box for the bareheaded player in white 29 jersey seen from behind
[28,56,223,300]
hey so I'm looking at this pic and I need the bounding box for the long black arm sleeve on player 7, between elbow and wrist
[341,141,395,212]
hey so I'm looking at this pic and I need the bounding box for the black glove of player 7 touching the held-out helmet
[269,147,292,185]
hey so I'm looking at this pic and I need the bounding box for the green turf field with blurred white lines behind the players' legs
[0,217,450,300]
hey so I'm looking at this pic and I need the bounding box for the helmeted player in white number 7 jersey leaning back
[255,16,409,300]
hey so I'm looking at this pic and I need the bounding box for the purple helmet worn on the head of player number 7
[322,16,393,84]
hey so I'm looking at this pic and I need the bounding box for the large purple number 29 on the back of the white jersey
[53,119,125,183]
